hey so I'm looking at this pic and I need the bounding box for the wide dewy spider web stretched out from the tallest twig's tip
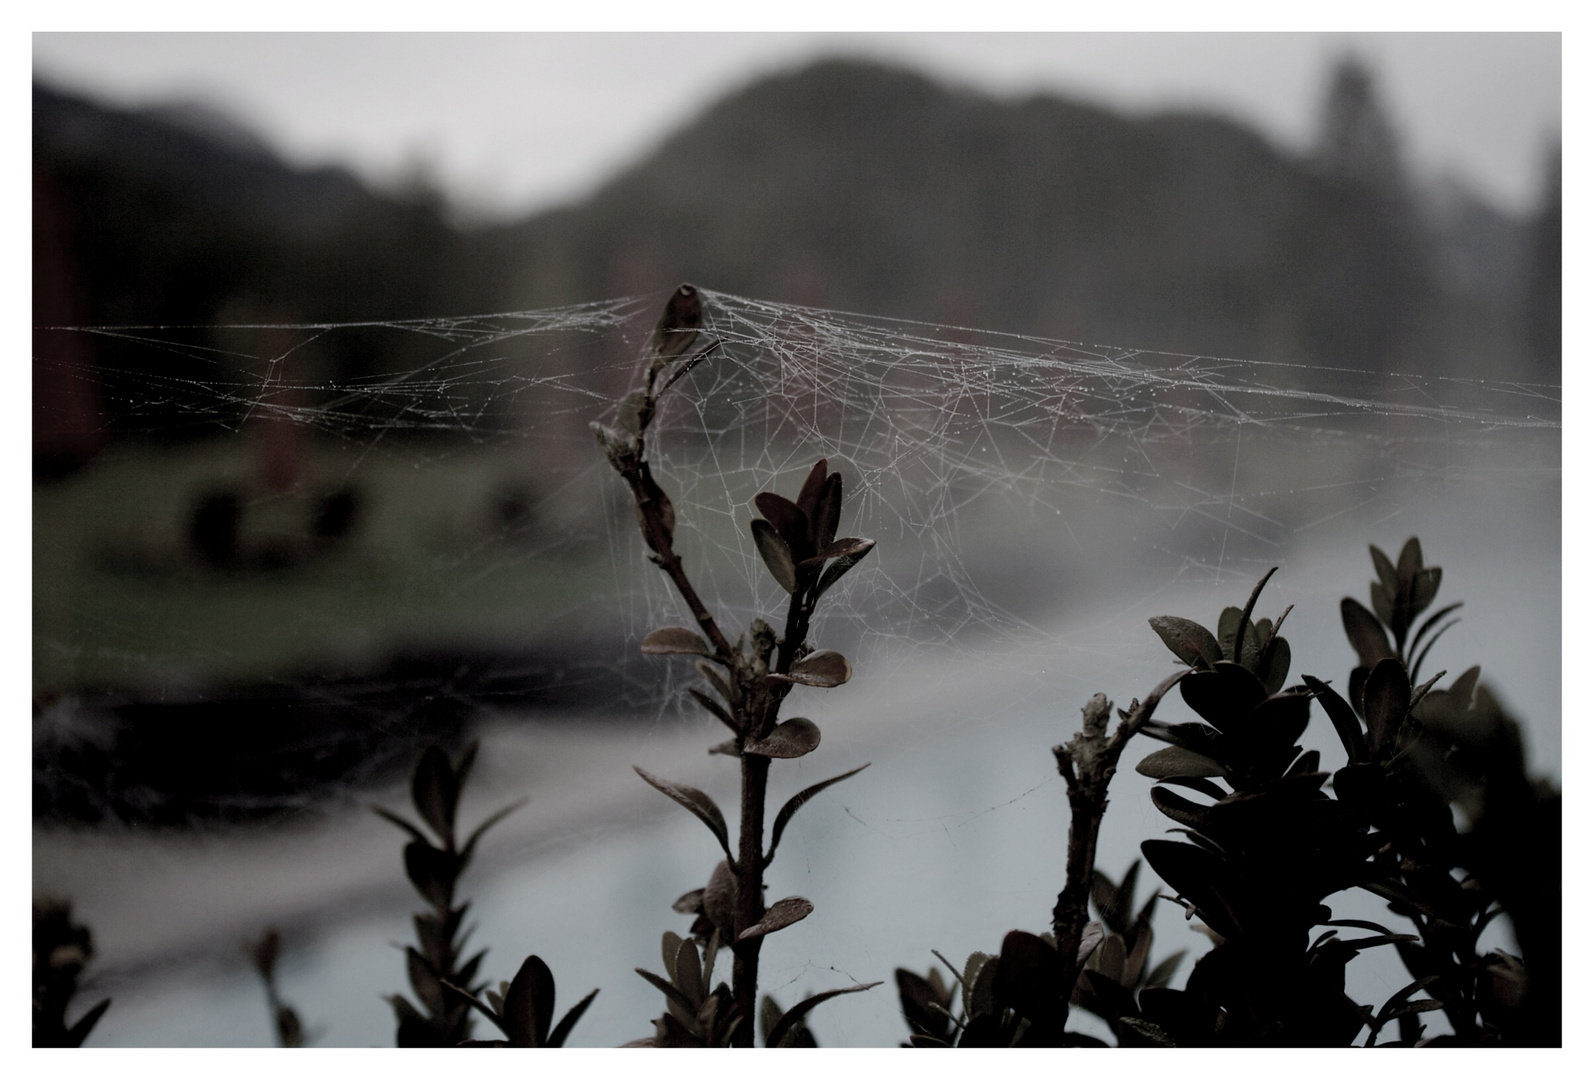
[35,292,1561,732]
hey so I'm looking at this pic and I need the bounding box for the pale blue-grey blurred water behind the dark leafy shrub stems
[35,491,1561,1045]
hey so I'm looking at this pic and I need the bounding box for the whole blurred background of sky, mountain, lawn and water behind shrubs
[33,33,1562,1045]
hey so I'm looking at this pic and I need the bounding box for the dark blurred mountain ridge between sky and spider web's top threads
[33,61,1548,452]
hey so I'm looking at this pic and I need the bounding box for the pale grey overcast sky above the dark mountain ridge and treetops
[33,33,1561,217]
